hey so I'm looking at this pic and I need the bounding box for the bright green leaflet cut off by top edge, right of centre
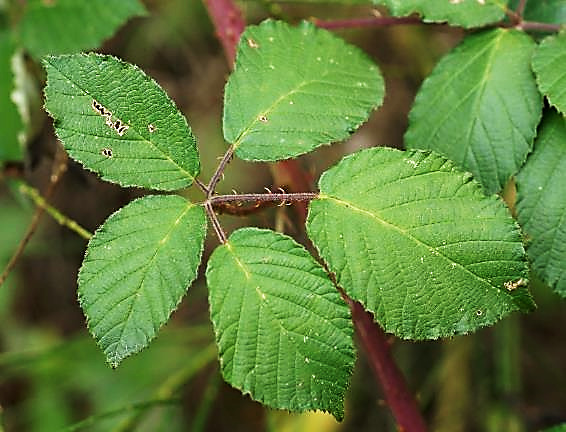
[373,0,507,28]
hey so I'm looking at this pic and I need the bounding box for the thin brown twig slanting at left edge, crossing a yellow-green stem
[0,145,68,286]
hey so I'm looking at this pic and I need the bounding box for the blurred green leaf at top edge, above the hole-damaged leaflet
[19,0,146,59]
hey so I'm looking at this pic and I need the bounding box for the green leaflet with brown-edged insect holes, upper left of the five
[44,54,200,190]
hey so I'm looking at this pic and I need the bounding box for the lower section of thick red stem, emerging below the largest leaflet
[347,299,426,432]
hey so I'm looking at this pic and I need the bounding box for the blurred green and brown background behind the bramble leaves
[0,0,566,432]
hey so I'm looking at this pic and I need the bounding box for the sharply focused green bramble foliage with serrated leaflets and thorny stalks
[1,0,566,426]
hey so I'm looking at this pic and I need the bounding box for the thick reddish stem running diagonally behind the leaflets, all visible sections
[203,0,426,432]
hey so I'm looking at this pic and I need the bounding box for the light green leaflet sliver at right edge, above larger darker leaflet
[533,31,566,114]
